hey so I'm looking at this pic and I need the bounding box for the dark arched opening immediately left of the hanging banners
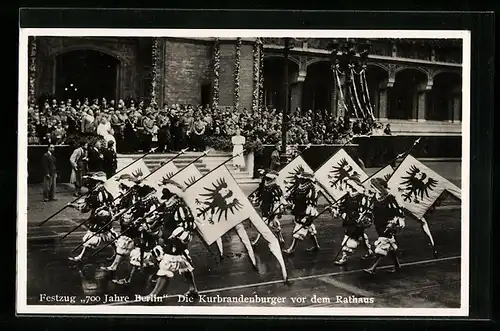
[302,61,333,113]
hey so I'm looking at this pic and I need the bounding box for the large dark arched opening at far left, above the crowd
[55,49,120,100]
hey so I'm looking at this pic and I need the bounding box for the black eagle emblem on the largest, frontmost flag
[195,178,243,224]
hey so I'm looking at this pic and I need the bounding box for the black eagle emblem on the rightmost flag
[398,165,438,203]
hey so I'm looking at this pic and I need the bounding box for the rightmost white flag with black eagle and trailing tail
[388,155,462,219]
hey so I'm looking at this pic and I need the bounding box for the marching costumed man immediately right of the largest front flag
[252,170,285,246]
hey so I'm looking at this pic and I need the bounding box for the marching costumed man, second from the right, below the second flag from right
[330,176,373,265]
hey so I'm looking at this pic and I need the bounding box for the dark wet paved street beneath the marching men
[22,162,461,308]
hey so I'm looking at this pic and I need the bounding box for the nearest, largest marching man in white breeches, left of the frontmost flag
[149,180,198,297]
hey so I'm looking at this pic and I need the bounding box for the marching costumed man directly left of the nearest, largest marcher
[102,185,160,278]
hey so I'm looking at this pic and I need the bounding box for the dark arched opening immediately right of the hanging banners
[366,64,389,118]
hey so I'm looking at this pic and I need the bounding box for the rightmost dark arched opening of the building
[427,72,462,121]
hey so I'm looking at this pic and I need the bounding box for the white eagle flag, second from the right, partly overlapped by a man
[314,149,368,200]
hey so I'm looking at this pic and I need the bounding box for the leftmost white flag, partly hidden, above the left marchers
[104,158,151,198]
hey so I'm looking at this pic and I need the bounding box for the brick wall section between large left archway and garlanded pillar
[164,40,212,104]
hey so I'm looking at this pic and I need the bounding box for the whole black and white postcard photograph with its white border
[16,29,471,316]
